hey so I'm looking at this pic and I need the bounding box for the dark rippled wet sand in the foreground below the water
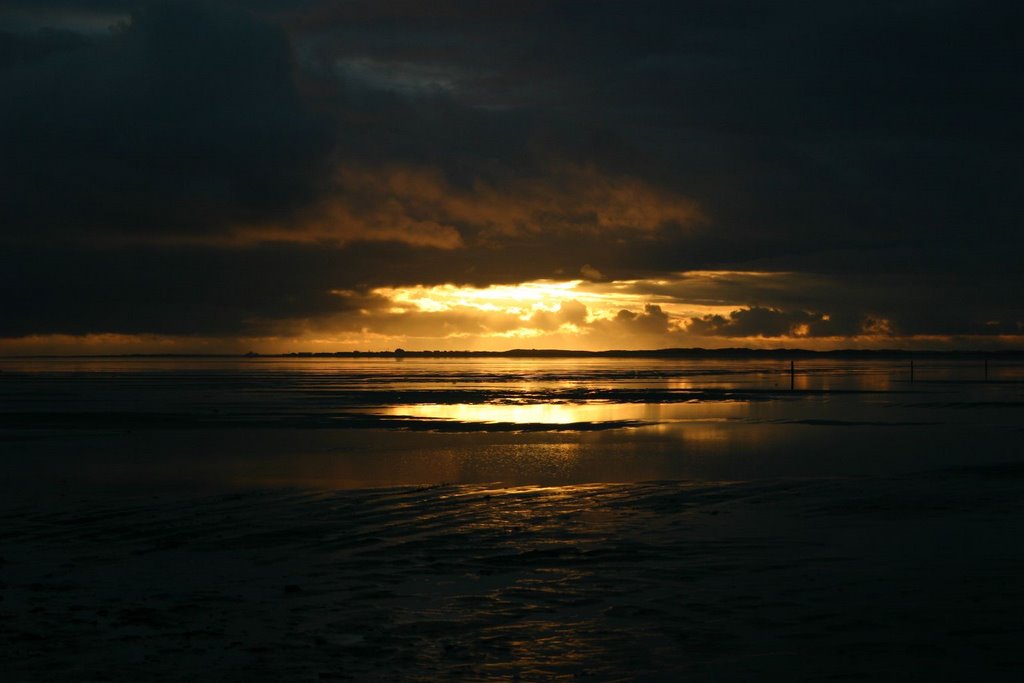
[0,465,1024,681]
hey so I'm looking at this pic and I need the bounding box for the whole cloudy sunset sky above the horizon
[0,0,1024,354]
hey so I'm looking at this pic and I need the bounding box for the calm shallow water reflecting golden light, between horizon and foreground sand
[0,358,1024,493]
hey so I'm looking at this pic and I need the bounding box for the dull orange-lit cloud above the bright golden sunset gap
[223,164,706,248]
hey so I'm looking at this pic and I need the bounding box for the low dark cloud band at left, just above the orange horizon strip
[0,245,362,337]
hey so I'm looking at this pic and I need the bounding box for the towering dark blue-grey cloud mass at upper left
[0,3,330,242]
